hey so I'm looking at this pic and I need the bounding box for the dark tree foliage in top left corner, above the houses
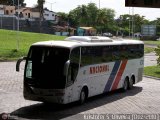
[0,0,26,7]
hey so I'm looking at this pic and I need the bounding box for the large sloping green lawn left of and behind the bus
[0,29,65,61]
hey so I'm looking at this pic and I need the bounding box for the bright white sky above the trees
[25,0,160,20]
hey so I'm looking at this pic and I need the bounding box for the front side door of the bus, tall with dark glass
[67,47,80,102]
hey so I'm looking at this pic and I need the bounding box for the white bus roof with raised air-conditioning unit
[33,36,144,48]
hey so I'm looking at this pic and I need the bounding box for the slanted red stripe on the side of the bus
[111,60,128,90]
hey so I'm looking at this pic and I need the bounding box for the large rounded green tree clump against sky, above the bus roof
[69,3,116,32]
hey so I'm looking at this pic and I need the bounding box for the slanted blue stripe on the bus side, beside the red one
[104,61,121,92]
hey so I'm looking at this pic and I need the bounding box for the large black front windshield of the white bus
[25,46,70,89]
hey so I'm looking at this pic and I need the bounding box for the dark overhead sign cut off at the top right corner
[125,0,160,8]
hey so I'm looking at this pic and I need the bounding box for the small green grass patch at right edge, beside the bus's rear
[144,66,160,78]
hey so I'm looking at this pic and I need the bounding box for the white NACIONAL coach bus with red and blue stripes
[16,36,144,104]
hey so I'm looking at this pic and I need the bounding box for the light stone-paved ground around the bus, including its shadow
[0,55,160,120]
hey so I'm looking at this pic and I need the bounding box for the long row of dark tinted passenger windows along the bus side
[81,45,144,65]
